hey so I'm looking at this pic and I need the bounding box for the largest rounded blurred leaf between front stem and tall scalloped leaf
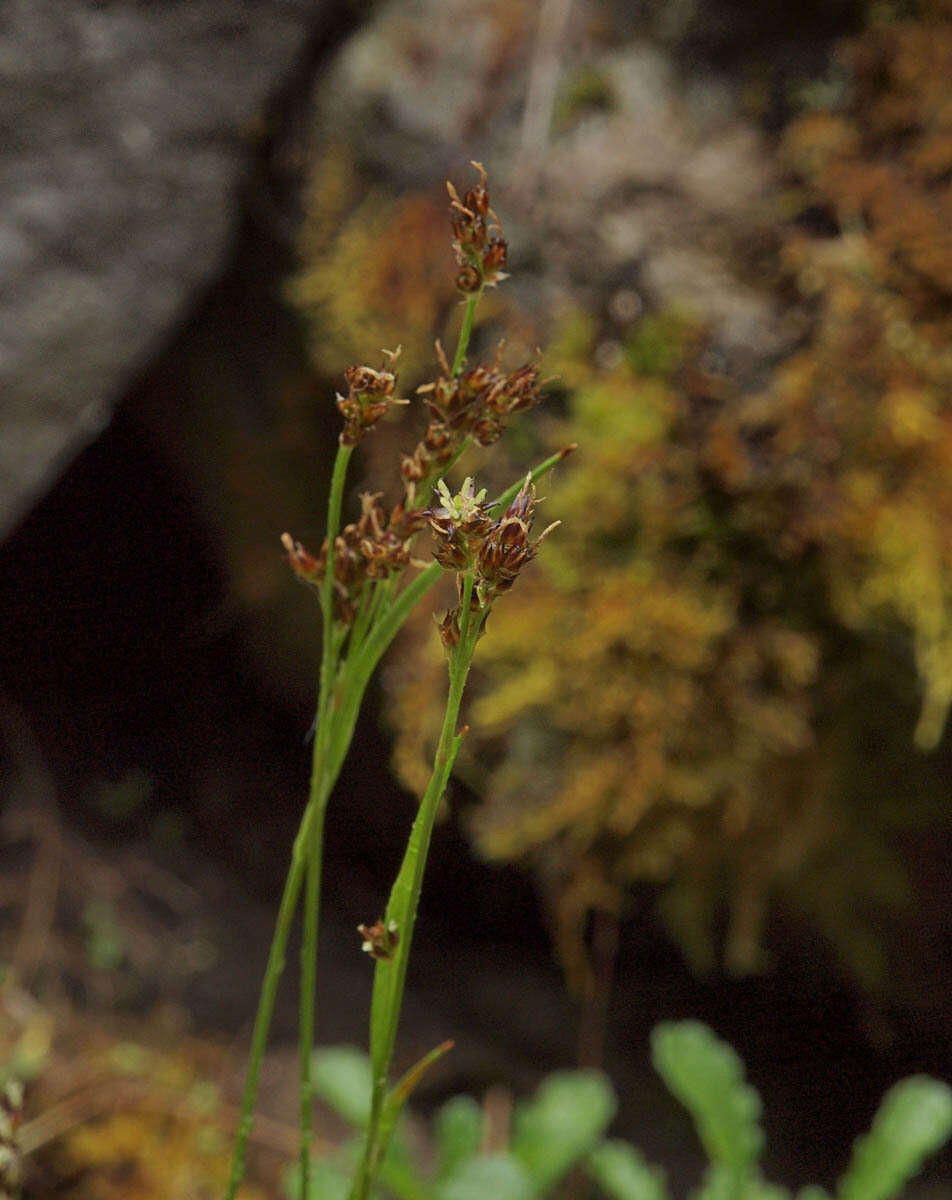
[511,1070,616,1192]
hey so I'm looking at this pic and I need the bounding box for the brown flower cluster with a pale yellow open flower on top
[424,475,559,649]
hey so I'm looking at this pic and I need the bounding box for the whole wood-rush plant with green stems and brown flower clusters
[227,163,571,1200]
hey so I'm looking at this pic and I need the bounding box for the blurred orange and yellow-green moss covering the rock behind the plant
[282,4,952,1007]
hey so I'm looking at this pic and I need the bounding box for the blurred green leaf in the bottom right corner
[837,1075,952,1200]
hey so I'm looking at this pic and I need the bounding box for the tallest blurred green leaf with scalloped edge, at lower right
[651,1021,764,1176]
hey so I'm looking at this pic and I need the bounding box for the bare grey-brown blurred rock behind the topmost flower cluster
[295,0,798,391]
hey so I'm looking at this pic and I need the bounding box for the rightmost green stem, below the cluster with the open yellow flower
[351,574,483,1200]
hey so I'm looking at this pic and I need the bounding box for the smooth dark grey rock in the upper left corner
[0,0,340,536]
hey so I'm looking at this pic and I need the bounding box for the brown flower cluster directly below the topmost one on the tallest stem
[400,344,541,504]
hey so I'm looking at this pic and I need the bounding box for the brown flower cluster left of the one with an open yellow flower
[281,492,426,625]
